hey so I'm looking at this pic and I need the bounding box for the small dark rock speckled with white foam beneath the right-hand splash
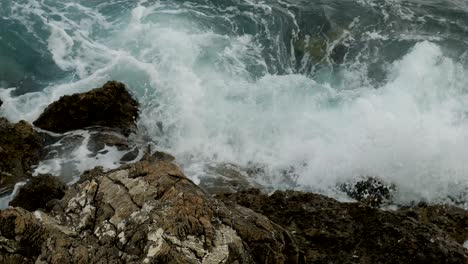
[340,177,395,207]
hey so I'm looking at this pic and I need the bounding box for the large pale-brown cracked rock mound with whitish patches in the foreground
[0,153,301,263]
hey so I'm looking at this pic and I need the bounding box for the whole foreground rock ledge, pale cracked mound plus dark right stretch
[0,152,468,263]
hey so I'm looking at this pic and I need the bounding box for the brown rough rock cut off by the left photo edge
[0,118,43,194]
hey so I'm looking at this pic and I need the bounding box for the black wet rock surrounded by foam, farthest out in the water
[34,81,138,135]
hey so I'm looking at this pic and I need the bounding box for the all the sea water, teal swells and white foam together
[0,0,468,208]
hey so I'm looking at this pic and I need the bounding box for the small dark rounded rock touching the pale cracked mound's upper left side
[9,175,67,212]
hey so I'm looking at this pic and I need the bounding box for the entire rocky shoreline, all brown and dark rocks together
[0,82,468,263]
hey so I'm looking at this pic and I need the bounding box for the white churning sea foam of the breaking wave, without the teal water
[0,0,468,206]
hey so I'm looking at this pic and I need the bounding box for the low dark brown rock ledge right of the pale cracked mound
[218,189,468,263]
